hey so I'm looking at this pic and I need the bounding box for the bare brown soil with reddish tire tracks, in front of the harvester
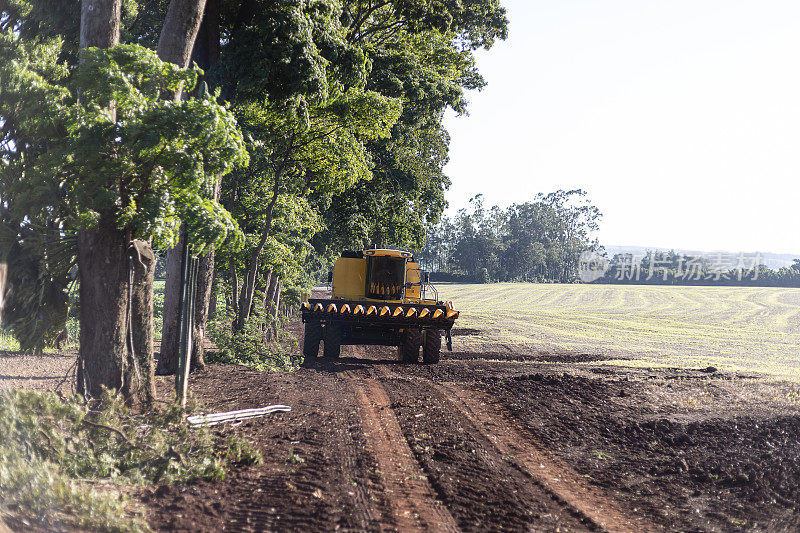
[0,324,800,531]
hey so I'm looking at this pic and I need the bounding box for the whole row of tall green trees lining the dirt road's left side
[0,0,508,404]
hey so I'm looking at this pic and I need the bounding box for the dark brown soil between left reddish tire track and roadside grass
[148,366,389,533]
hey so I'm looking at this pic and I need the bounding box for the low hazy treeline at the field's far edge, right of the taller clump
[595,251,800,287]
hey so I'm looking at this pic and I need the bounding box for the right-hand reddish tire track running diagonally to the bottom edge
[379,366,660,533]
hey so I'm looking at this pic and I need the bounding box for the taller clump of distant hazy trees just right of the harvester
[418,190,602,283]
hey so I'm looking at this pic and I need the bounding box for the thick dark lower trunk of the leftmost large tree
[77,221,130,398]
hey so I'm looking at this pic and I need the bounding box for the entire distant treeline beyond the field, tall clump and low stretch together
[417,190,800,287]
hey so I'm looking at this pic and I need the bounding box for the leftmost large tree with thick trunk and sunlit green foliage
[0,2,246,396]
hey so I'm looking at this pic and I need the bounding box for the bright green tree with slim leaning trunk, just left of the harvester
[226,93,401,329]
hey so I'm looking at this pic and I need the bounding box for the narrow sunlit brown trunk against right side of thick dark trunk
[129,239,156,408]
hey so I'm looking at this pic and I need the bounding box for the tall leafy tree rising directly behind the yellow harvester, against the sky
[315,0,508,254]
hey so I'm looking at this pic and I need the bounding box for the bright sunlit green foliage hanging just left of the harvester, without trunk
[220,89,401,316]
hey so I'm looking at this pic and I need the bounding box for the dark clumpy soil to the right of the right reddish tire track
[484,374,800,530]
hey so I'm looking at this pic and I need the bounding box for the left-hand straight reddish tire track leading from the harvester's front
[344,372,460,532]
